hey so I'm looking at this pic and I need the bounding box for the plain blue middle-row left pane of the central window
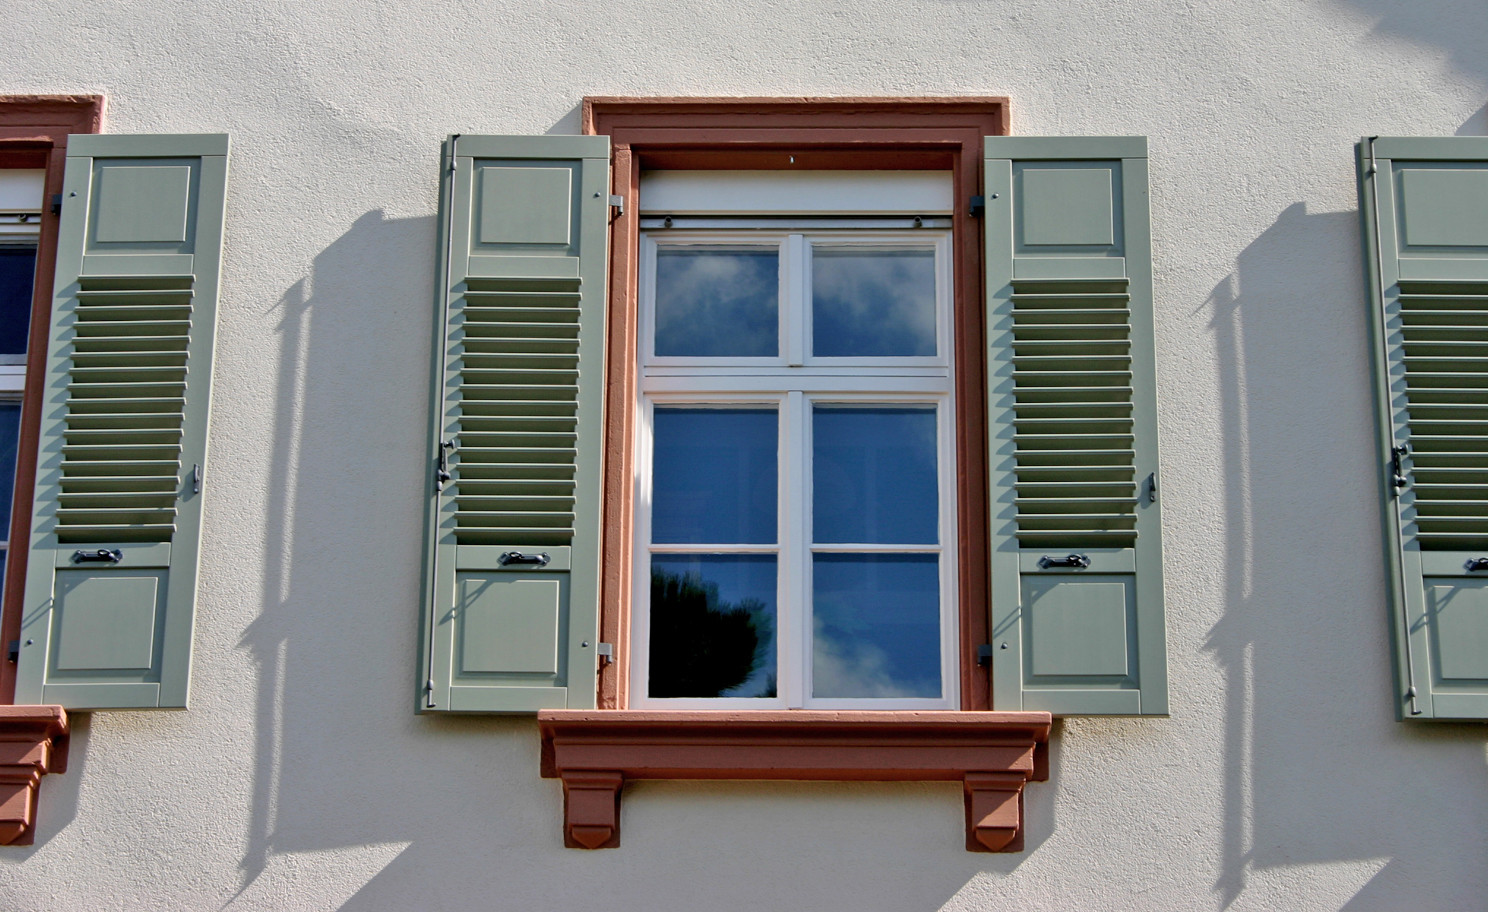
[652,408,780,545]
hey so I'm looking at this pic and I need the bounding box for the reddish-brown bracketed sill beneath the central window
[537,710,1052,852]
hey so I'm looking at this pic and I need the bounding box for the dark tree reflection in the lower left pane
[650,568,775,698]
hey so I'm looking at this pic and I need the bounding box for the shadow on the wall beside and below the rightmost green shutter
[1207,204,1488,911]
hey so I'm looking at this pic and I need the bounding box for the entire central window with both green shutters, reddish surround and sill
[418,98,1167,851]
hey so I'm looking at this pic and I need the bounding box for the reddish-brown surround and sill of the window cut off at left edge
[0,95,104,845]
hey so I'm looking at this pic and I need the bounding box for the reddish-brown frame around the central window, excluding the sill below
[582,97,1009,710]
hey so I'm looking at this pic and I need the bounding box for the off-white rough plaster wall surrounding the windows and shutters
[0,0,1488,912]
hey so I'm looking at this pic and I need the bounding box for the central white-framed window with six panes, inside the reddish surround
[631,179,958,708]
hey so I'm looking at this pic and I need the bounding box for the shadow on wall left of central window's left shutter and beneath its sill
[228,211,1035,912]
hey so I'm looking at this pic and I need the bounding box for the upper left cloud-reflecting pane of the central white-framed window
[656,247,780,357]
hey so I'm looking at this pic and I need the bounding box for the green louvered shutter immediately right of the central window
[985,137,1168,716]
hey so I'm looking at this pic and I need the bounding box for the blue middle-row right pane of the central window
[811,406,940,545]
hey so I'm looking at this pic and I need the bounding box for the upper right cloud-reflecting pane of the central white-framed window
[811,247,934,357]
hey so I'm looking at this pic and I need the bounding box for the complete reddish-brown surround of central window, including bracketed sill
[553,97,1052,851]
